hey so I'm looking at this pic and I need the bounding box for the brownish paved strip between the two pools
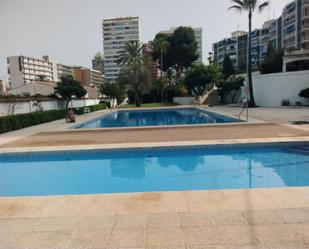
[0,123,309,148]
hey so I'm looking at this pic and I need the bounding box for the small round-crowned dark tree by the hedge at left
[54,75,87,109]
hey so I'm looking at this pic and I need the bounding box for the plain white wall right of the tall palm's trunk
[253,71,309,107]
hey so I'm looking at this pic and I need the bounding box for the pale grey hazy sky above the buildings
[0,0,290,80]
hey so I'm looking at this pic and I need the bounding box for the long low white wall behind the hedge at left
[0,99,100,116]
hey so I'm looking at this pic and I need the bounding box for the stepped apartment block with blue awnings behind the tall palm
[213,0,309,70]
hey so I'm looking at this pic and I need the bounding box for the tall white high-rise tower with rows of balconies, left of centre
[102,17,139,82]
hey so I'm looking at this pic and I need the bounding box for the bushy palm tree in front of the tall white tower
[118,41,151,107]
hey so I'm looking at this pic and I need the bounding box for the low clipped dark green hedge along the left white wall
[0,103,106,134]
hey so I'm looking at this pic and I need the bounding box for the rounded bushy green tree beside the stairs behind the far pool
[185,64,219,96]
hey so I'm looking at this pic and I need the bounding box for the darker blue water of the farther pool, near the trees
[74,108,241,129]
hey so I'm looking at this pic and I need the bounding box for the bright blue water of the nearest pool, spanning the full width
[0,145,309,196]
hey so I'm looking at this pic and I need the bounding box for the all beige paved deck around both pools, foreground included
[0,108,309,249]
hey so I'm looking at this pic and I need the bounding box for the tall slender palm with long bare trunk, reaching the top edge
[229,0,269,107]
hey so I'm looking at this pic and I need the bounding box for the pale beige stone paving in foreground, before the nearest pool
[0,188,309,249]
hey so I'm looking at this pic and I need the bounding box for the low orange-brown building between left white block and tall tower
[74,67,103,88]
